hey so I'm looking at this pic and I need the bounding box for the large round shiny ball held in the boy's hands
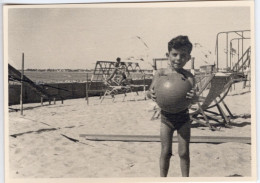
[154,73,192,113]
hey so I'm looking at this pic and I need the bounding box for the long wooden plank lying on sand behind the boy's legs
[79,134,251,144]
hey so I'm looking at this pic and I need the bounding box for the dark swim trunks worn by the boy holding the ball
[161,109,190,130]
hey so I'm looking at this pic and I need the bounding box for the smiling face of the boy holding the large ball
[166,48,191,70]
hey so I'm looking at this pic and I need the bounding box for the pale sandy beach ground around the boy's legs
[8,83,252,178]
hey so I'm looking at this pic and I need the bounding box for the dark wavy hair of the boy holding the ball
[168,36,192,53]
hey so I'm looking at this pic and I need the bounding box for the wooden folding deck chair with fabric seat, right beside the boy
[190,74,243,130]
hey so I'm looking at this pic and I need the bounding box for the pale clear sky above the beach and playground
[8,2,251,69]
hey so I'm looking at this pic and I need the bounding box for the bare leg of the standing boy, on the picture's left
[160,122,173,177]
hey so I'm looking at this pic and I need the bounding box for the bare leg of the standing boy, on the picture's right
[178,122,190,177]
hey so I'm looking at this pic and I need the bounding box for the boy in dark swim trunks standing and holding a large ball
[147,36,197,177]
